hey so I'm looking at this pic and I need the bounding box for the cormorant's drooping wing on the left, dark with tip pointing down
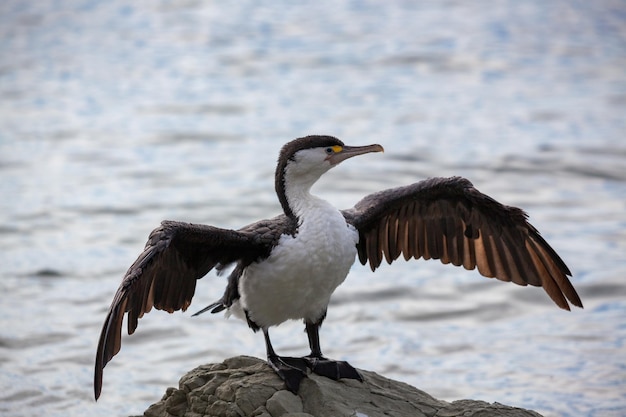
[94,218,284,399]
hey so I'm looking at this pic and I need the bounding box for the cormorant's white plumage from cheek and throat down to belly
[230,148,359,328]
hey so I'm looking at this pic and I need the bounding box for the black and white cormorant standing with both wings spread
[94,135,583,400]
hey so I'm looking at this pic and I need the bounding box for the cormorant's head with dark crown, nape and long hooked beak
[276,135,384,218]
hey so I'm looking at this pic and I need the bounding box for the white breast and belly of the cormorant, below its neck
[232,205,358,328]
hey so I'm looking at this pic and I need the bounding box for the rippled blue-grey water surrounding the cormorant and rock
[0,0,626,416]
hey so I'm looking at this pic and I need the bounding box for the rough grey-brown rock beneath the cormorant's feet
[144,356,541,417]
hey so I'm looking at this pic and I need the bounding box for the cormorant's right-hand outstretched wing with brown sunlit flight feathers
[342,177,582,310]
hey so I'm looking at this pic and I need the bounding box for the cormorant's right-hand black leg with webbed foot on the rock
[304,318,363,382]
